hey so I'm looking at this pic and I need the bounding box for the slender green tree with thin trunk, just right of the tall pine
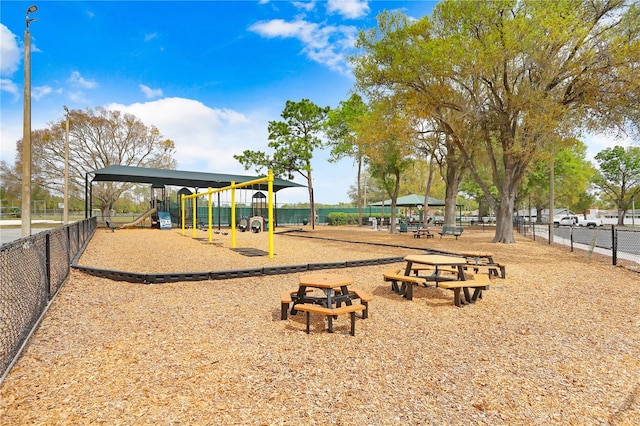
[326,93,368,226]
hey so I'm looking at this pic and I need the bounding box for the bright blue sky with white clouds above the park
[0,0,632,203]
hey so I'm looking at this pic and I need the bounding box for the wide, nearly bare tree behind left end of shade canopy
[0,107,176,220]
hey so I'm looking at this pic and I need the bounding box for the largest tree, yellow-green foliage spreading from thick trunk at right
[355,0,640,243]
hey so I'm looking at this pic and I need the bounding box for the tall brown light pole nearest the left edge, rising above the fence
[22,5,38,238]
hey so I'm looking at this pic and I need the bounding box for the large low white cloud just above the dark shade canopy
[101,98,353,203]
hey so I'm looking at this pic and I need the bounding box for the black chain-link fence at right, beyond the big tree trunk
[517,221,640,272]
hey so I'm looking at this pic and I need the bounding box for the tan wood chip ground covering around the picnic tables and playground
[0,227,640,425]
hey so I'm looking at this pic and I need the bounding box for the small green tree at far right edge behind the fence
[595,146,640,225]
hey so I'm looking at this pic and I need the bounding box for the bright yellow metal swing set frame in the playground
[180,170,273,259]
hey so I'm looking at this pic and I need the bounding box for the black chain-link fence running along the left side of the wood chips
[0,217,97,384]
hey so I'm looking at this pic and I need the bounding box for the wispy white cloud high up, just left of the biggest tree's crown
[249,19,357,74]
